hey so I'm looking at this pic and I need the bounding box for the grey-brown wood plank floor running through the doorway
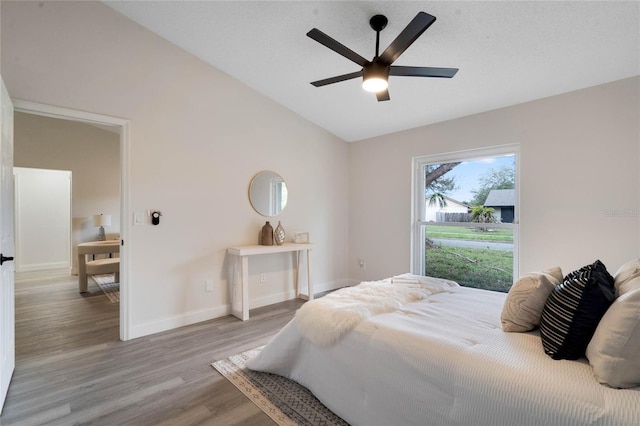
[0,274,302,426]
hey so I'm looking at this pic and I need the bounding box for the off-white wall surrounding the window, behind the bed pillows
[349,77,640,280]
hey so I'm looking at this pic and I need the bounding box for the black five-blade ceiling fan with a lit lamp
[307,12,458,102]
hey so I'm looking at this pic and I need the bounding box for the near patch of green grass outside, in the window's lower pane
[426,246,513,293]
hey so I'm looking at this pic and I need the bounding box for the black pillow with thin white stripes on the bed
[540,260,615,359]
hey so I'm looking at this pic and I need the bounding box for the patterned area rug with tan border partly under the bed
[211,347,348,426]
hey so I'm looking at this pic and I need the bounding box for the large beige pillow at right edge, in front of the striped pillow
[586,289,640,388]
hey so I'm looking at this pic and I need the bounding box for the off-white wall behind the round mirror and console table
[1,2,348,337]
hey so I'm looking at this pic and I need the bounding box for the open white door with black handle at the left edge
[0,77,16,413]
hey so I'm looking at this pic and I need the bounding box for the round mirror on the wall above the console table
[249,170,287,216]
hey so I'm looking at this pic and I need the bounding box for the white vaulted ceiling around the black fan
[104,1,640,142]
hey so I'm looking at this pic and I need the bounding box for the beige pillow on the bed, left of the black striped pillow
[500,266,562,332]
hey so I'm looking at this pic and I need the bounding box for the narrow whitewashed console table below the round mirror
[227,243,313,321]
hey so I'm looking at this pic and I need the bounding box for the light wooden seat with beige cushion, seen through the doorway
[78,240,120,293]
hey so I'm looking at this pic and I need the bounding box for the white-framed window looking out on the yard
[411,145,519,292]
